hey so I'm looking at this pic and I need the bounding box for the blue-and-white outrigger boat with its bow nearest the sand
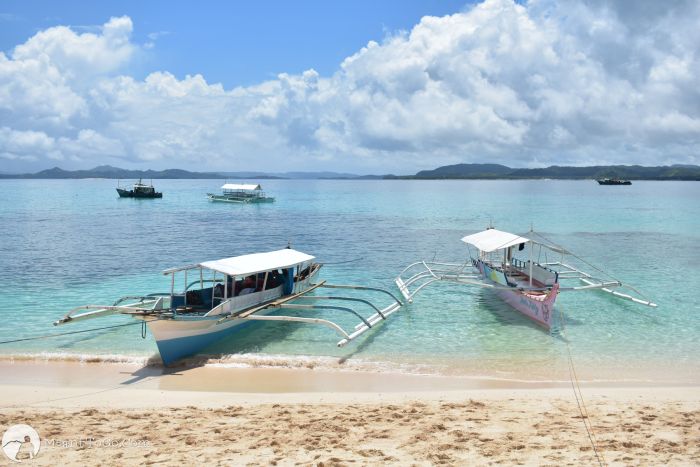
[54,248,402,365]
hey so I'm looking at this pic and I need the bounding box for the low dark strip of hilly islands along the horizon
[0,164,700,181]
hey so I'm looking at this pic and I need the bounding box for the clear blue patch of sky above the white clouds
[0,0,467,88]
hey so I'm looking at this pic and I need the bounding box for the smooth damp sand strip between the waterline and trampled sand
[0,361,700,406]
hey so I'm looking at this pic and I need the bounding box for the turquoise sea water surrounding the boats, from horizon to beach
[0,179,700,383]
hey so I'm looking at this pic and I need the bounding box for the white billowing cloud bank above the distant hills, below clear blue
[0,0,700,173]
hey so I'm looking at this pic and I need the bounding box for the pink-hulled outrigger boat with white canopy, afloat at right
[396,228,657,329]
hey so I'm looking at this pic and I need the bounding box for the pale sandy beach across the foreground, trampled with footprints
[0,363,700,465]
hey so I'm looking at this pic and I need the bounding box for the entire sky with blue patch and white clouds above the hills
[0,0,700,174]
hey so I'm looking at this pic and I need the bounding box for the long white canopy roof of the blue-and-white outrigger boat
[197,248,314,276]
